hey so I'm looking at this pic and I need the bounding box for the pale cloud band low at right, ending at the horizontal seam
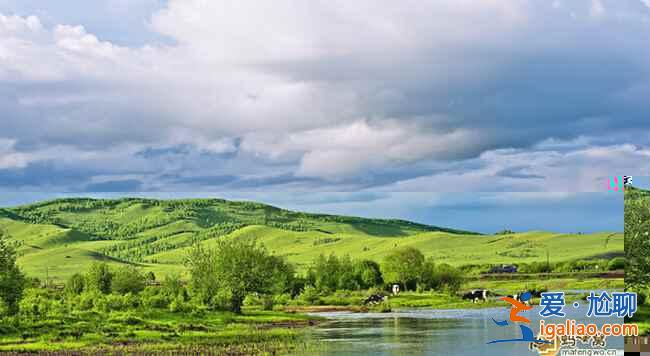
[383,144,650,192]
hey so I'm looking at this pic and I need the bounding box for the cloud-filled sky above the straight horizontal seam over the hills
[0,0,650,194]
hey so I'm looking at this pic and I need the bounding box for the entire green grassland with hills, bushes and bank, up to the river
[0,198,623,354]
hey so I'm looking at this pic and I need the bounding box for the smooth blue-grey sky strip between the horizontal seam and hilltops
[0,192,623,233]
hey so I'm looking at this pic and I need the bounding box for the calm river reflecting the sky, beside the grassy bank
[300,305,623,356]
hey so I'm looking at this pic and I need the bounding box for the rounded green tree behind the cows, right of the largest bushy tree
[382,247,424,291]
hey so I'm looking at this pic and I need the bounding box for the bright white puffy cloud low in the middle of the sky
[241,120,481,180]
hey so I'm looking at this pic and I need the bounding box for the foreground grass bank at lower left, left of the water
[0,308,320,355]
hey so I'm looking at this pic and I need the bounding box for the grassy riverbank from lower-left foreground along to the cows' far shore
[0,279,624,355]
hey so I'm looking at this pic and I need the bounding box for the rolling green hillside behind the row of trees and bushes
[0,198,623,279]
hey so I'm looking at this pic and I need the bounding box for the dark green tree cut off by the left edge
[0,230,25,315]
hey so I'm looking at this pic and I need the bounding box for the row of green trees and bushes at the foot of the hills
[0,225,462,317]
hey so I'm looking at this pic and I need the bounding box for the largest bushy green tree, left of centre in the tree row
[187,238,287,314]
